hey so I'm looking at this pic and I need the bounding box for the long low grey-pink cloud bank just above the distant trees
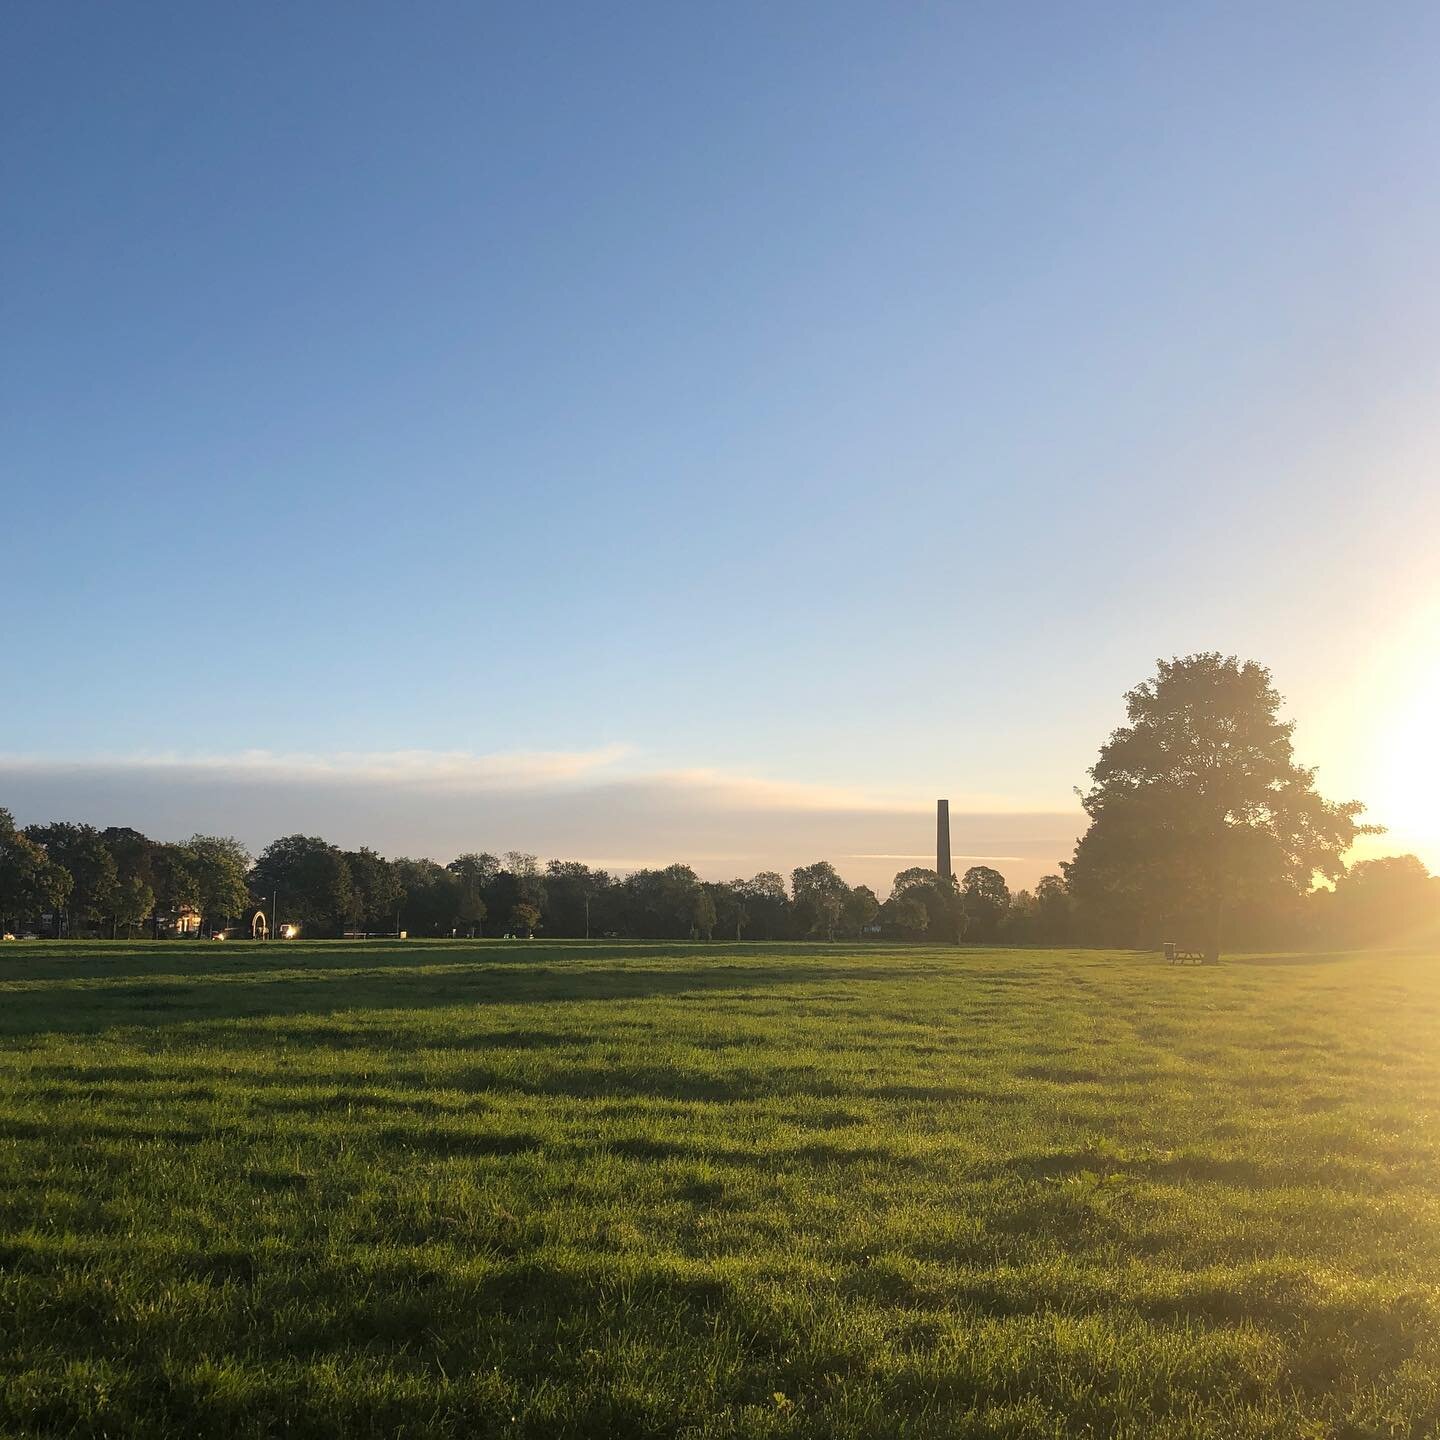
[0,744,1080,891]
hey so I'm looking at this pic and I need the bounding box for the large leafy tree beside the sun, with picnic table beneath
[1063,652,1374,960]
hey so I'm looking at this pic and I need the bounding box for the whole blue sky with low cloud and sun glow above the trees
[0,0,1440,883]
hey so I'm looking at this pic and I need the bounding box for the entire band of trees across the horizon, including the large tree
[0,652,1440,958]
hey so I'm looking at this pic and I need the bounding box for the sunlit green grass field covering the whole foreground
[0,943,1440,1440]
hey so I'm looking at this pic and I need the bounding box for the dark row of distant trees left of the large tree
[0,809,1042,940]
